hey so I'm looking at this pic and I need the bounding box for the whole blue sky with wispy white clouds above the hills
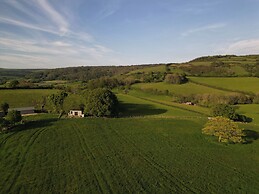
[0,0,259,68]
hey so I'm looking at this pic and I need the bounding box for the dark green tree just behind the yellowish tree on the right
[212,104,238,120]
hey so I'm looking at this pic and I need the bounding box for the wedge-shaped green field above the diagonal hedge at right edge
[190,77,259,93]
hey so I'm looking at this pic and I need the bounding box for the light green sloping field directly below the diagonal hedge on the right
[132,82,231,95]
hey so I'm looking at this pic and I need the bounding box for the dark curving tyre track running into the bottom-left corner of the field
[1,128,47,193]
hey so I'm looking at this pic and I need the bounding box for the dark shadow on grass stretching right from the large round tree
[119,102,167,117]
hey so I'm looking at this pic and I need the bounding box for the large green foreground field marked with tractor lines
[0,116,259,193]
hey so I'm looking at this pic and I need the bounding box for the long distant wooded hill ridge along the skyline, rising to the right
[0,55,259,81]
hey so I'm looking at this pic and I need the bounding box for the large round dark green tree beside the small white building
[85,88,119,117]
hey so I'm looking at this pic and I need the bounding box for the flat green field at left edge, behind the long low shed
[0,89,57,108]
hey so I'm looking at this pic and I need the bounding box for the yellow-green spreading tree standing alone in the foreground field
[202,117,245,143]
